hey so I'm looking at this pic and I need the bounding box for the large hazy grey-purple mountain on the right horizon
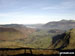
[42,20,75,30]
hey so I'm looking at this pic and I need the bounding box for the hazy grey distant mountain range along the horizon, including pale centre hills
[25,20,75,30]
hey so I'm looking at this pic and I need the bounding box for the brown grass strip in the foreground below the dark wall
[0,49,59,56]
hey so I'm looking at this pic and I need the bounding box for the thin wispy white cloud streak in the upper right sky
[42,0,75,10]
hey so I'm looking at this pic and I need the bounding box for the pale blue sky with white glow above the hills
[0,0,75,24]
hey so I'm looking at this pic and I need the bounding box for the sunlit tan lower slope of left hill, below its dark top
[0,32,24,40]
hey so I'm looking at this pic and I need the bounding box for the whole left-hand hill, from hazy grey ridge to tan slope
[0,24,35,40]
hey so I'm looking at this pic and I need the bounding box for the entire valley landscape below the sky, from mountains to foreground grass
[0,21,75,55]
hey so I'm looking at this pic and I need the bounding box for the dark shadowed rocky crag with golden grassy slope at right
[51,29,75,49]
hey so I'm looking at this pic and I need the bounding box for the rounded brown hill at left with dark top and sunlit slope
[0,27,25,40]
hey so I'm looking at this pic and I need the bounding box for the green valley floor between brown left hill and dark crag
[24,29,62,48]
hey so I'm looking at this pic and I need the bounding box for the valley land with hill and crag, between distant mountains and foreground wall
[0,26,75,49]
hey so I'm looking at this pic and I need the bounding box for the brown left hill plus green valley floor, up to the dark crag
[0,27,63,48]
